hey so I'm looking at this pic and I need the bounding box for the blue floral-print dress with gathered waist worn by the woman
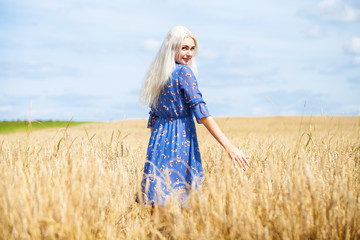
[137,64,210,206]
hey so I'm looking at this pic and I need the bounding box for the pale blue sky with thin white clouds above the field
[0,0,360,121]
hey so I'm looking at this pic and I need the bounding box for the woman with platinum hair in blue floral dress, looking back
[137,26,249,205]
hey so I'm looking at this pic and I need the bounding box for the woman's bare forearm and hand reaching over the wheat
[200,116,250,171]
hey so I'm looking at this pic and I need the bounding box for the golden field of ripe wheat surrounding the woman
[0,116,360,240]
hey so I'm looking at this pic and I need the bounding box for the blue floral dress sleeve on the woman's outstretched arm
[180,66,210,123]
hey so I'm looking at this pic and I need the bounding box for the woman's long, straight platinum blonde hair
[140,26,198,107]
